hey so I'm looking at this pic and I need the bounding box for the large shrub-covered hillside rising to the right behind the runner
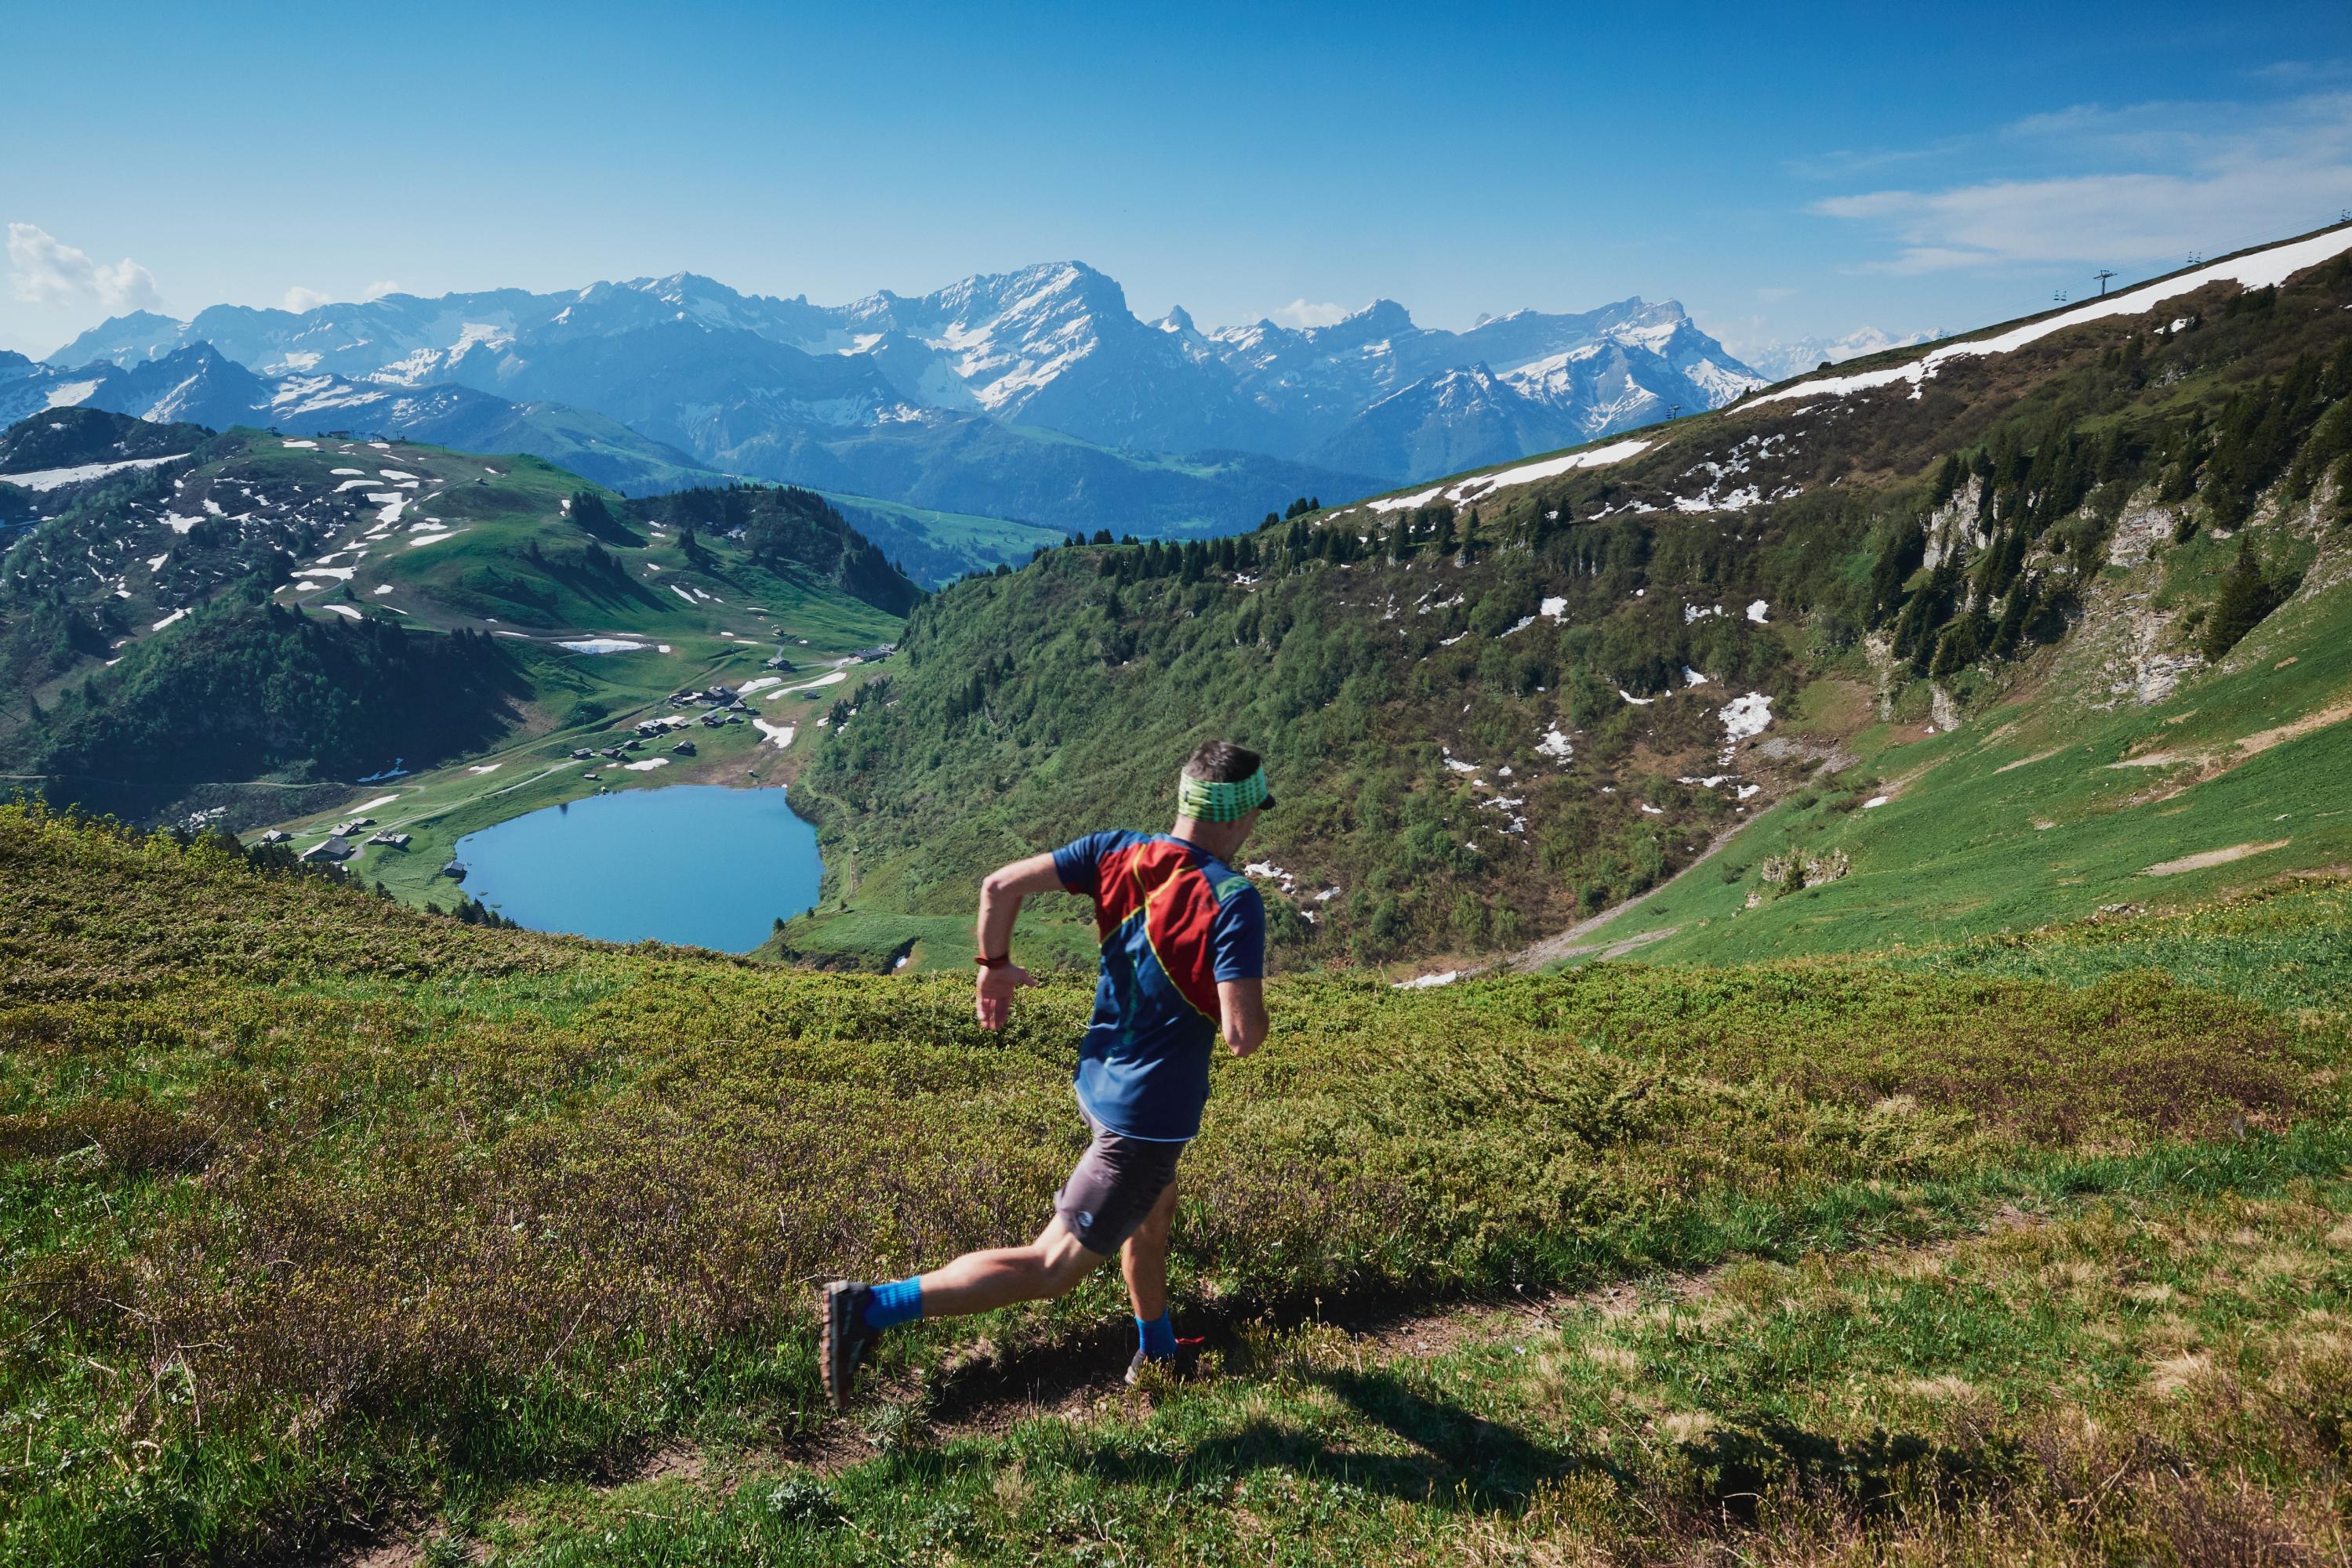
[786,230,2352,968]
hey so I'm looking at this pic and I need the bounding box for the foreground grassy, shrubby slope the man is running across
[0,806,2352,1563]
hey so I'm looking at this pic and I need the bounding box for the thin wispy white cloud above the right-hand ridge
[1813,94,2352,275]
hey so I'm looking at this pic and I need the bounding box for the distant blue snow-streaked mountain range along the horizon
[0,261,1762,534]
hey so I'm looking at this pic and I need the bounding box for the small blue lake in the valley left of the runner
[456,785,823,952]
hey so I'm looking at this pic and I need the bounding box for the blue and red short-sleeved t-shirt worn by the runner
[1054,829,1265,1142]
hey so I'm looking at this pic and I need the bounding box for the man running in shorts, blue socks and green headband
[821,741,1275,1410]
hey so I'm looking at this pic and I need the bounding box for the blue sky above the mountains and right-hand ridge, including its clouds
[0,0,2352,355]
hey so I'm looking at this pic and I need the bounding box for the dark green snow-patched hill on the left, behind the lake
[0,430,920,846]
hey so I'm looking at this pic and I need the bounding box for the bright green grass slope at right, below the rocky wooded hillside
[1588,557,2352,964]
